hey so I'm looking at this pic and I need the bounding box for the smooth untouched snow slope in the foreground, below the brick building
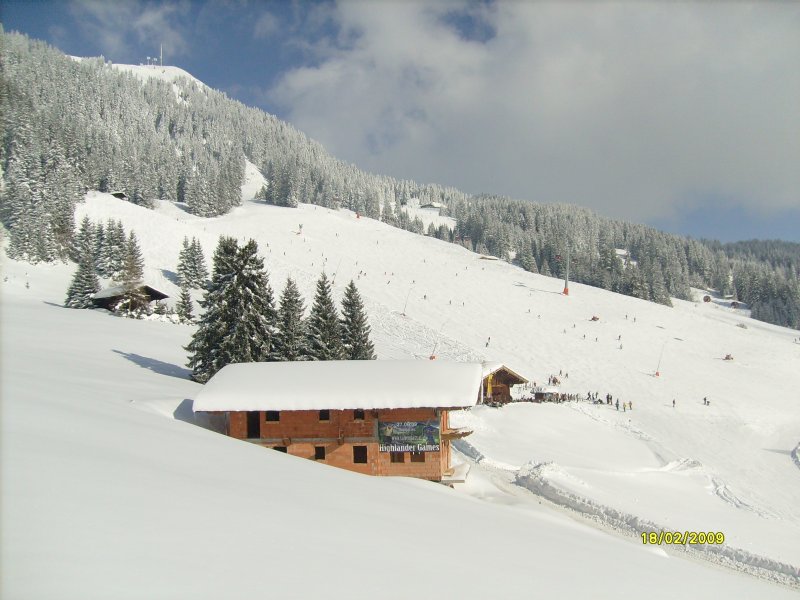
[0,247,794,599]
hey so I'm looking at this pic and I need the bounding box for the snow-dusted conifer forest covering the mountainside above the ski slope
[0,30,800,328]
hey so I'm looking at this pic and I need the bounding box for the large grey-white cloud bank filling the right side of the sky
[272,2,800,220]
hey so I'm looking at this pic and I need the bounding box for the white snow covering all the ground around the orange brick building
[0,166,800,599]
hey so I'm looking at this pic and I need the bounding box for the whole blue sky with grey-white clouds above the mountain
[0,0,800,241]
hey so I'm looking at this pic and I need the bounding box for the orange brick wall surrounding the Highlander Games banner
[225,408,466,481]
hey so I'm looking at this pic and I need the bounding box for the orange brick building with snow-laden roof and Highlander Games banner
[194,360,483,483]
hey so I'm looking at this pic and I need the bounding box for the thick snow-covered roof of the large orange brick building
[193,360,482,411]
